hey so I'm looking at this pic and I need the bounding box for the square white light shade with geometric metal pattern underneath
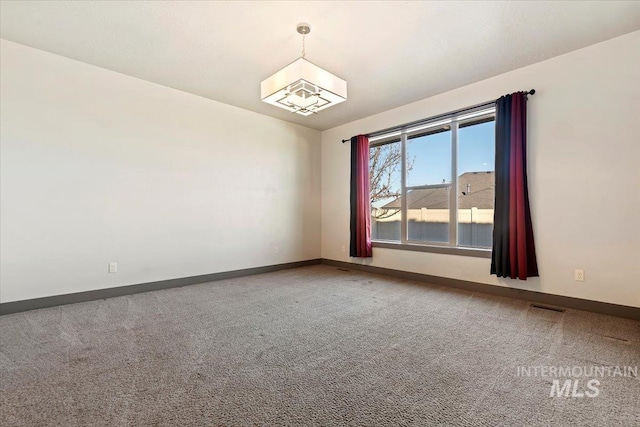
[260,58,347,116]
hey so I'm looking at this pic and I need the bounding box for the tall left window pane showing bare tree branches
[369,140,402,241]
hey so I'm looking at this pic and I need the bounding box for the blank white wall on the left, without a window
[0,40,320,302]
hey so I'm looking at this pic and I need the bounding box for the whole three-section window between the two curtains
[369,104,495,254]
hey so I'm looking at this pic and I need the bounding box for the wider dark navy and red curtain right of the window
[491,92,538,280]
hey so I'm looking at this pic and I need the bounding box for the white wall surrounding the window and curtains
[322,32,640,307]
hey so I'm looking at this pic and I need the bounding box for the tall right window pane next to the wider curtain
[458,121,495,248]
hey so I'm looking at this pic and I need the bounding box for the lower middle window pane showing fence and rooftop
[407,186,451,243]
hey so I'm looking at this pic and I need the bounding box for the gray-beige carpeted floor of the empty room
[0,266,640,426]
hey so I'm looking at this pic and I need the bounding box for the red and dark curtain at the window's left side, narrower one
[349,135,373,258]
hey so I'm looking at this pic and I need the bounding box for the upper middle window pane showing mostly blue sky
[407,126,451,187]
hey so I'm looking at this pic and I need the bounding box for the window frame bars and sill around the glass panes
[369,103,496,258]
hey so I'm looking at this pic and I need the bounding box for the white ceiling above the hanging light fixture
[0,0,640,130]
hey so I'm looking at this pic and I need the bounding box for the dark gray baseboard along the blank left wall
[0,258,321,315]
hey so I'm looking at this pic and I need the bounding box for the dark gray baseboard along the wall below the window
[322,258,640,320]
